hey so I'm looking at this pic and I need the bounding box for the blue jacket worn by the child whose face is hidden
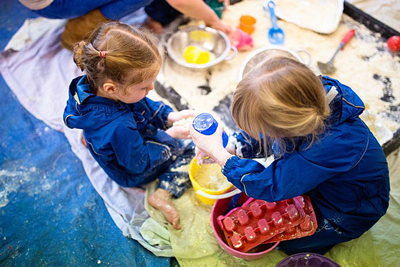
[222,77,389,238]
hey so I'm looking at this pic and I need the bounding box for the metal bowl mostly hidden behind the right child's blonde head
[238,45,311,81]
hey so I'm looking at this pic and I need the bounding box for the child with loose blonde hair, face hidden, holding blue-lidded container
[190,57,389,254]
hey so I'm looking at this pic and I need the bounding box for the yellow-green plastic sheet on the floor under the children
[146,149,400,267]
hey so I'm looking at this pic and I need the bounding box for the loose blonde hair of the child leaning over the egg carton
[231,57,330,155]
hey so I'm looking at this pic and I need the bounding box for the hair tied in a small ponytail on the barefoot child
[74,22,161,90]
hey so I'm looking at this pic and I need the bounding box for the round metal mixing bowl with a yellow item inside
[165,26,237,69]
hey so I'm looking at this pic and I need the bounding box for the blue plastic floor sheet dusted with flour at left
[0,75,170,266]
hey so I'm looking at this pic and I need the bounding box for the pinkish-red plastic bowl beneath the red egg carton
[211,194,279,260]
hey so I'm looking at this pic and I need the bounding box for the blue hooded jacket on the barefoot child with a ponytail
[64,76,180,187]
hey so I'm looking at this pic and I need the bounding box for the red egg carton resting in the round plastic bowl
[217,196,317,252]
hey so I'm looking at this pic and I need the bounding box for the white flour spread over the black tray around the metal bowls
[164,0,400,147]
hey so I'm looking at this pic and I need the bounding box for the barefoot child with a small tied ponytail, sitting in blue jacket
[64,22,195,229]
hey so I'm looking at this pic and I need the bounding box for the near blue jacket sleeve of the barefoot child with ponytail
[112,124,171,175]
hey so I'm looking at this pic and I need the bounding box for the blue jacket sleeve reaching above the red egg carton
[222,151,338,202]
